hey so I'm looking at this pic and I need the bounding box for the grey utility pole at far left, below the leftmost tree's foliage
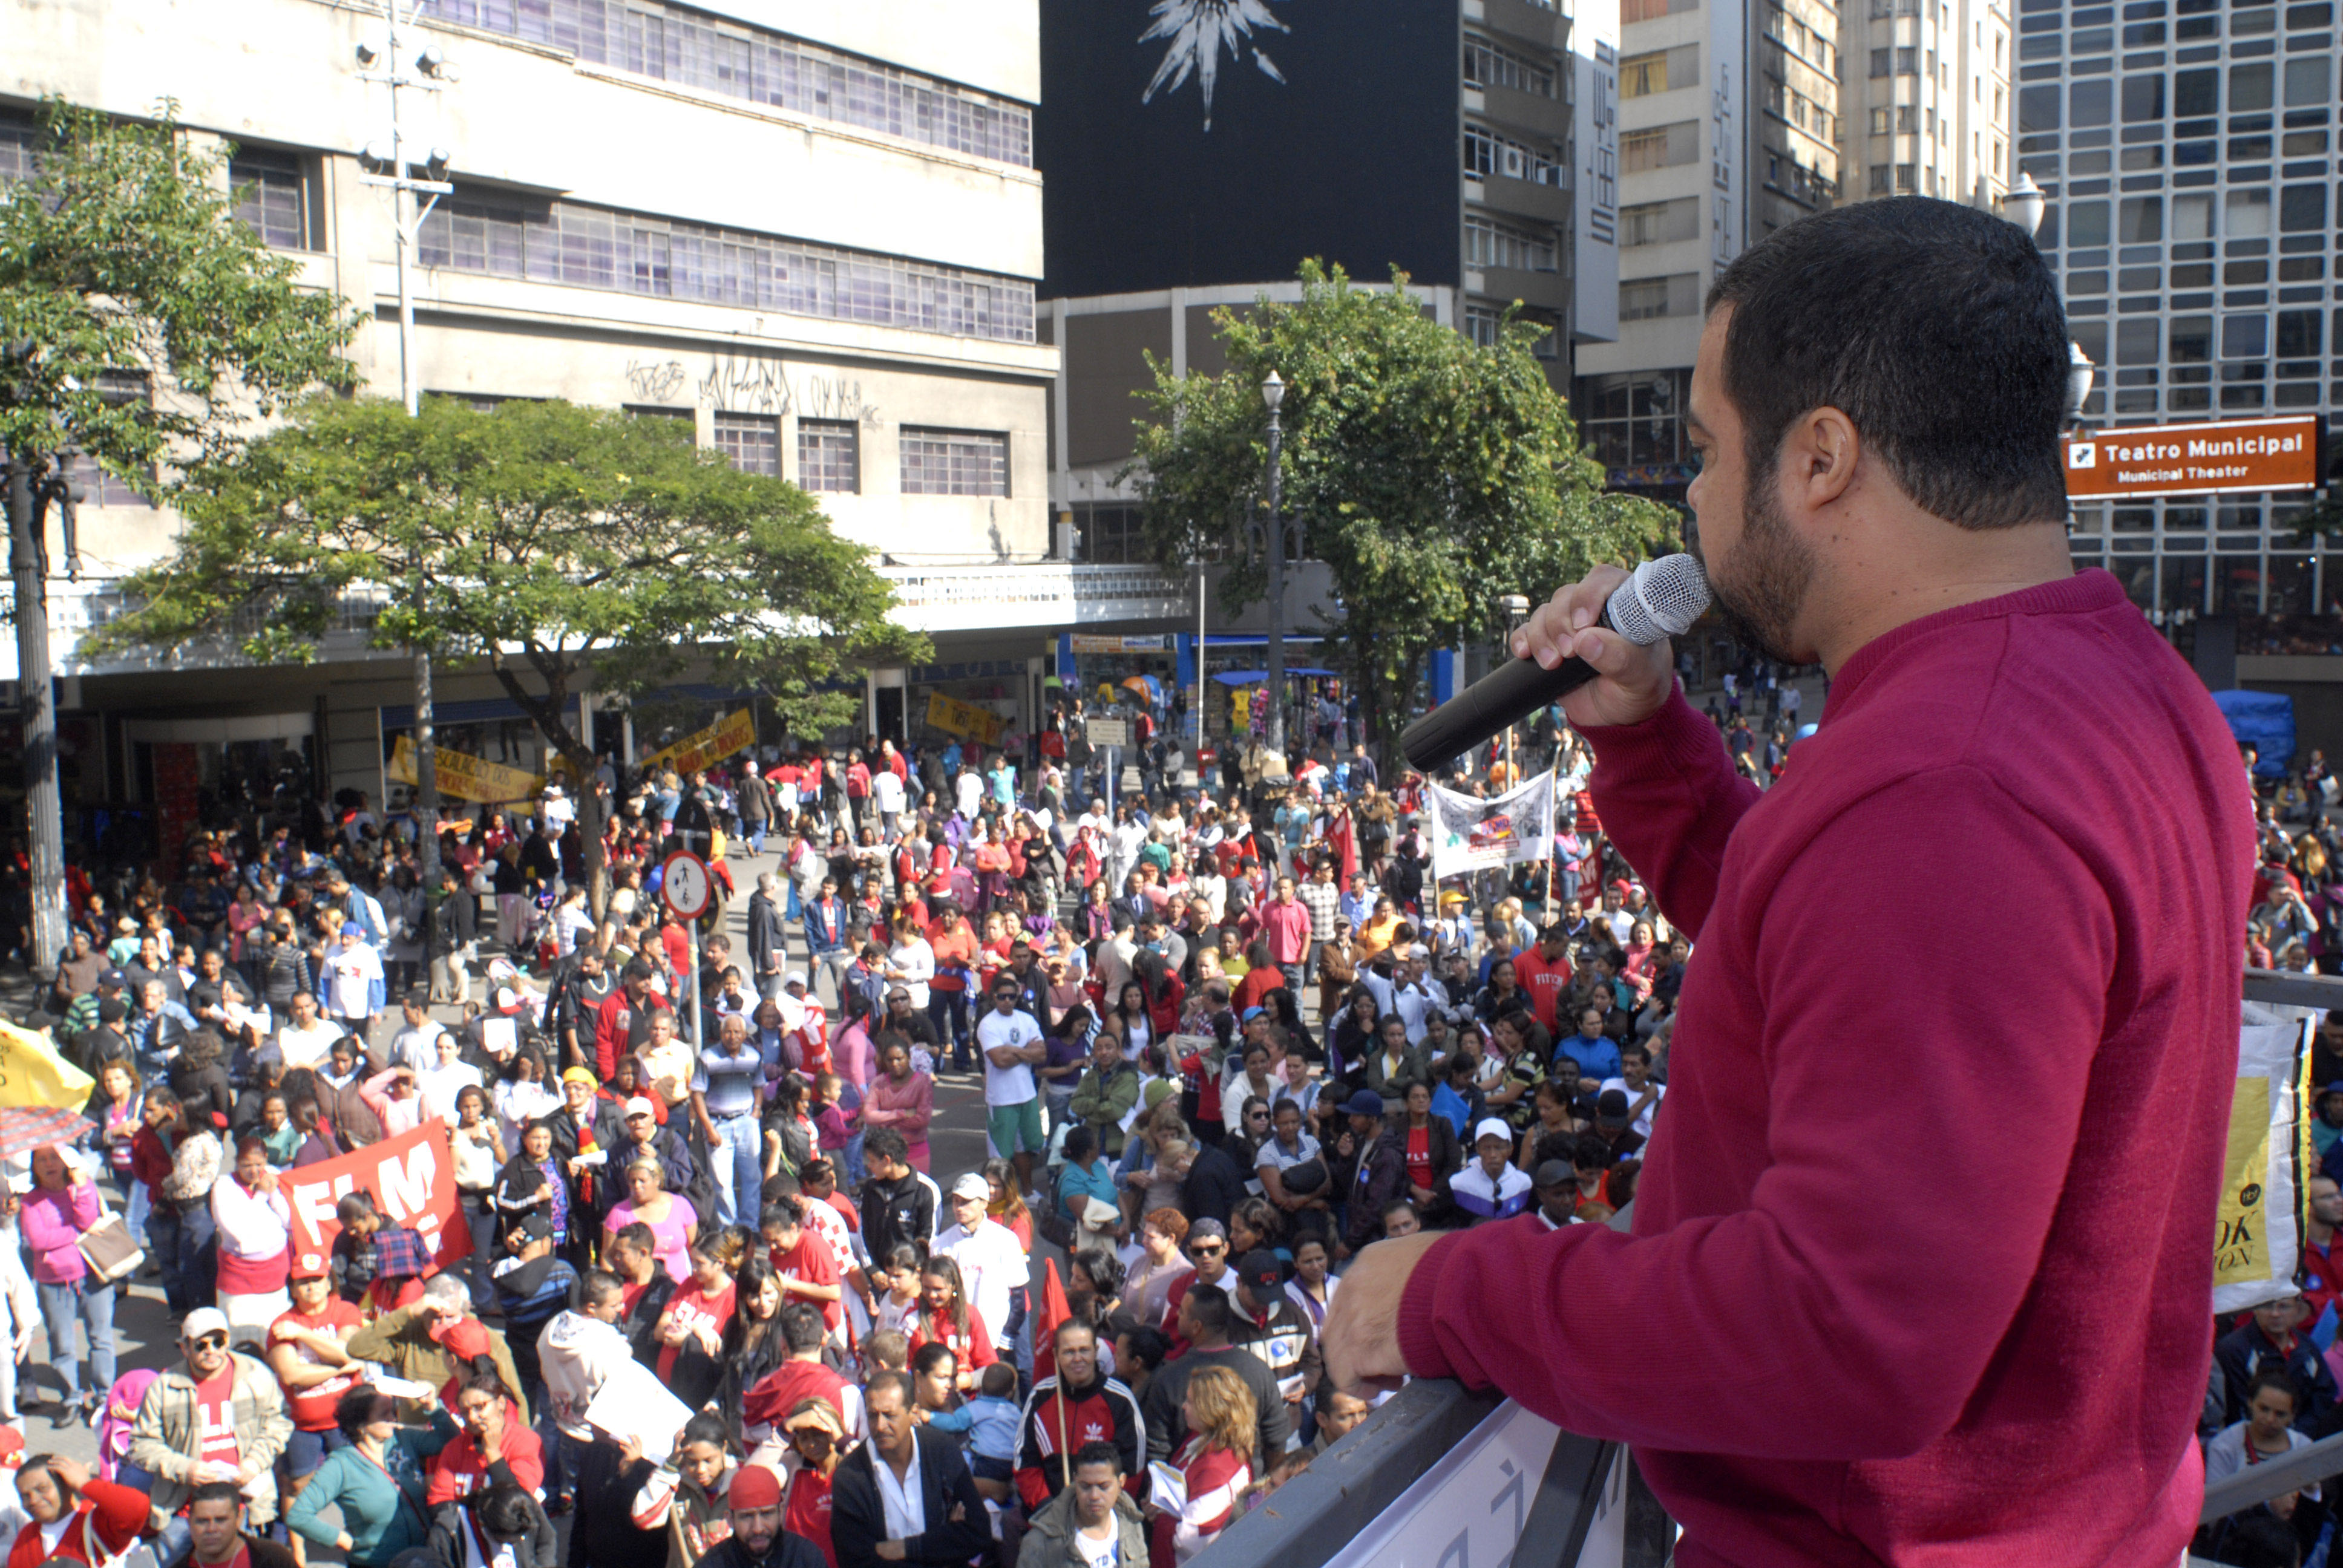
[7,445,73,980]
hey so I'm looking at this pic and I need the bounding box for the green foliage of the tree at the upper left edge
[0,99,358,490]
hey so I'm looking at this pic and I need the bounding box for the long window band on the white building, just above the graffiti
[417,192,1034,342]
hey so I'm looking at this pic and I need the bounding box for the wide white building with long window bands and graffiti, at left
[0,0,1115,809]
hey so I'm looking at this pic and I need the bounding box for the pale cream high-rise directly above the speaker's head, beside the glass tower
[1840,0,2015,211]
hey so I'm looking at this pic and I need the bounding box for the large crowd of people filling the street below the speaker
[7,679,1855,1568]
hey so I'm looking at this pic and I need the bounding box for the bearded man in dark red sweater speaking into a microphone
[1324,201,2254,1568]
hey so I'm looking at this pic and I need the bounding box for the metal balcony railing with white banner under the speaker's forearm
[1207,970,2343,1568]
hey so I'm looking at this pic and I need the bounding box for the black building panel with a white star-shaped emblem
[1034,0,1462,298]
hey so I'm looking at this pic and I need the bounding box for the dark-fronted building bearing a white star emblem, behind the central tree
[1034,0,1619,717]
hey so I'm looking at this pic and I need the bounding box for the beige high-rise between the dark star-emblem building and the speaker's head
[1575,0,1841,499]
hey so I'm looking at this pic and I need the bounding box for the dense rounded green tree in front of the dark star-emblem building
[1132,260,1675,759]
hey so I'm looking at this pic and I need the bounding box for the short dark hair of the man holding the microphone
[1708,197,2066,530]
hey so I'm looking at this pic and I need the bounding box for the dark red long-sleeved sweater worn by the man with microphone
[1399,572,2254,1568]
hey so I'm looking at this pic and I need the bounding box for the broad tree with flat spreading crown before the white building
[103,399,928,909]
